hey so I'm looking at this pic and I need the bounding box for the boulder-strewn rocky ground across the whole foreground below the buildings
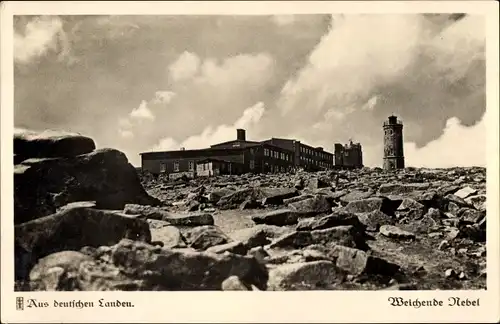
[14,129,486,290]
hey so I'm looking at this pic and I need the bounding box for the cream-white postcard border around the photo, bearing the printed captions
[0,1,500,323]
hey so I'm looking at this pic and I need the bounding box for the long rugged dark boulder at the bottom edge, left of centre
[111,240,268,290]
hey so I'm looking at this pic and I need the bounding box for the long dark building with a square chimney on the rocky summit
[140,129,360,177]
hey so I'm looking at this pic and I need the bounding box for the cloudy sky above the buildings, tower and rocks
[14,14,486,167]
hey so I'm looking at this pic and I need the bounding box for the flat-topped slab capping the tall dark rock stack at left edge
[14,129,96,164]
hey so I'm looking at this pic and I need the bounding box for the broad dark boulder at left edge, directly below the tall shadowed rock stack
[14,207,151,278]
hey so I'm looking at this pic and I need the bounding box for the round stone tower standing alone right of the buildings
[384,115,405,170]
